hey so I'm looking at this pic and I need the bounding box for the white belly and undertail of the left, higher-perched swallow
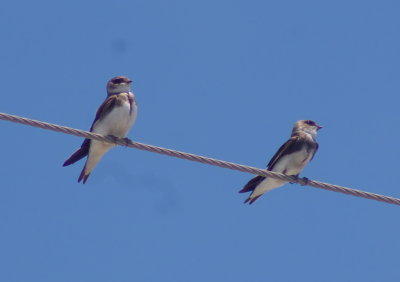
[85,98,137,175]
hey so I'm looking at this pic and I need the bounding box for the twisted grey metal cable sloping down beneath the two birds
[0,113,400,205]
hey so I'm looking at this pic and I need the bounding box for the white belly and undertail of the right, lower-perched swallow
[250,150,312,198]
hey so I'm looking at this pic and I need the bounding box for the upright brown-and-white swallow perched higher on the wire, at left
[63,76,137,183]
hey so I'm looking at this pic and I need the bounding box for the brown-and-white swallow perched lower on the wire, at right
[239,120,322,204]
